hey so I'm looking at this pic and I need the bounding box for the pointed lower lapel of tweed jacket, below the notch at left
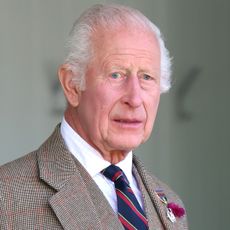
[49,172,102,230]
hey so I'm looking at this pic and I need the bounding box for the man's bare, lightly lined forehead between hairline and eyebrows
[93,27,160,63]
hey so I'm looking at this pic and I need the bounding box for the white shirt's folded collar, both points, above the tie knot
[61,117,133,182]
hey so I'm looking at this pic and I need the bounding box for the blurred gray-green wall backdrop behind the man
[0,0,230,230]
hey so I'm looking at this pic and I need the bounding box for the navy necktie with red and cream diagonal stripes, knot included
[102,165,148,230]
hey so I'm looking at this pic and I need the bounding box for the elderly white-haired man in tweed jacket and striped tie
[0,5,187,230]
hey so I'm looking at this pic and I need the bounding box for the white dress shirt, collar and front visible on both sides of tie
[61,118,143,213]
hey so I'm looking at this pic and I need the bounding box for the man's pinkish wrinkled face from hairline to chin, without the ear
[74,28,160,154]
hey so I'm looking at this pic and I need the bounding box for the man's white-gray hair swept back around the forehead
[65,4,171,92]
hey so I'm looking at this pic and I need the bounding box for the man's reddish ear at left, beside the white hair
[58,64,81,107]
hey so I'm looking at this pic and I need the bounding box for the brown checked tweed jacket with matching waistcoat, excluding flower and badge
[0,126,187,230]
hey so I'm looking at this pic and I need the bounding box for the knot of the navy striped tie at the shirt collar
[102,165,128,182]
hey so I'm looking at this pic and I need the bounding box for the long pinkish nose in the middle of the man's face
[122,76,142,108]
